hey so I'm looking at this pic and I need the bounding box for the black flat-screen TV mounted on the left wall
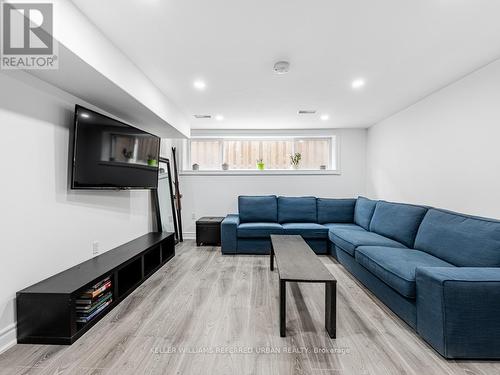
[71,105,160,189]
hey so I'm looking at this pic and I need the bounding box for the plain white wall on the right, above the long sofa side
[367,61,500,219]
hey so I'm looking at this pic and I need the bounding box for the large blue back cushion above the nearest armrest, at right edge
[415,209,500,267]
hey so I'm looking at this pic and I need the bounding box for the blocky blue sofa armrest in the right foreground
[416,267,500,359]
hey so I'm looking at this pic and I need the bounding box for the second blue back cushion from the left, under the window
[278,197,317,223]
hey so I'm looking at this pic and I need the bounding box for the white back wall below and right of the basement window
[180,129,366,237]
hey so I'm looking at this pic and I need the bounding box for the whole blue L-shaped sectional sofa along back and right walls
[221,195,500,359]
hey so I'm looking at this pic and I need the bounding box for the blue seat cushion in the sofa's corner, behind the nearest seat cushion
[329,229,405,256]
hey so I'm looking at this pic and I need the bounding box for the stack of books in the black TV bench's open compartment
[76,277,113,323]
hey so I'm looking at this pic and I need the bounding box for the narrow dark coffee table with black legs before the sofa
[271,234,337,339]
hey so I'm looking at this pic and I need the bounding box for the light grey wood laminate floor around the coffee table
[0,241,500,375]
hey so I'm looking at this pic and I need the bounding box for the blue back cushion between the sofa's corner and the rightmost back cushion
[370,201,428,247]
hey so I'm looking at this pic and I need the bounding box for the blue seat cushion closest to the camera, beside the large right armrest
[355,246,455,298]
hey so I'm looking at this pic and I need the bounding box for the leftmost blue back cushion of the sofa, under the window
[238,195,278,223]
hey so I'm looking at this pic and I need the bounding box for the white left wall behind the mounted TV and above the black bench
[0,72,152,351]
